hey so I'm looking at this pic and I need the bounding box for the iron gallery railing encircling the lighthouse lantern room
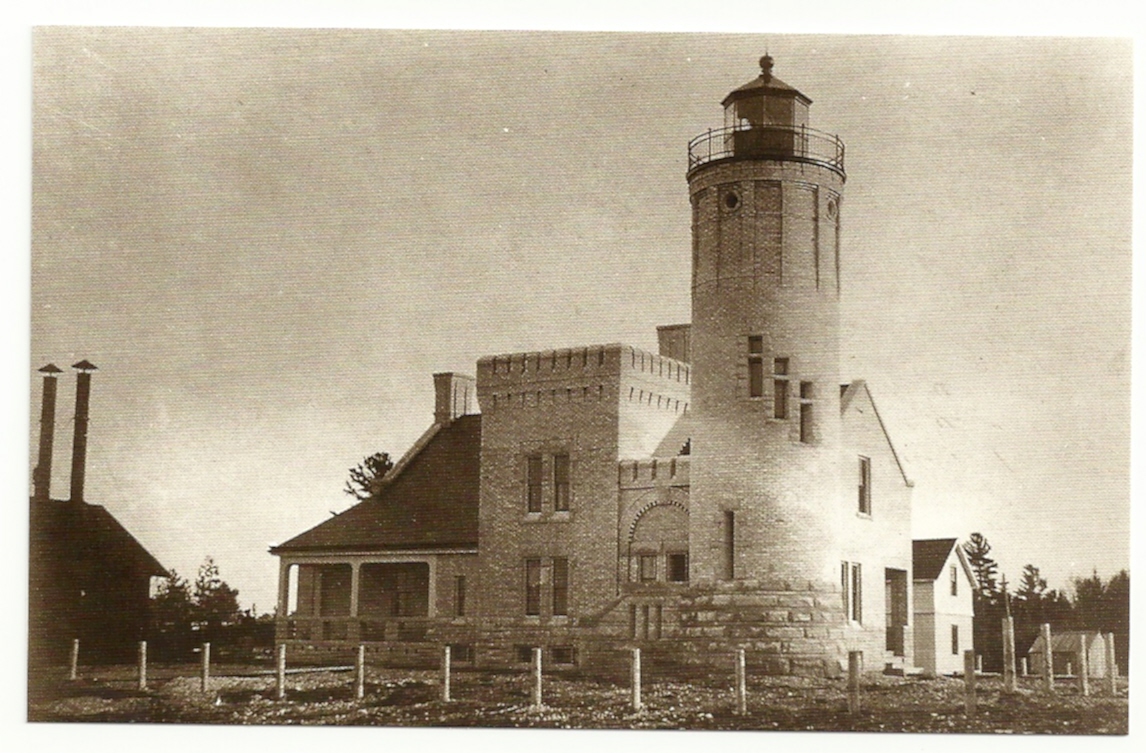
[689,125,846,178]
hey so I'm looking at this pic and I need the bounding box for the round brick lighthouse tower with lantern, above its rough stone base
[688,55,846,589]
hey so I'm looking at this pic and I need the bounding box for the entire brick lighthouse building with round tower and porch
[272,56,958,674]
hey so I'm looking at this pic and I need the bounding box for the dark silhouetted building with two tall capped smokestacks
[28,361,166,667]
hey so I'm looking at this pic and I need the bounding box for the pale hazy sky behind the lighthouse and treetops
[26,28,1133,612]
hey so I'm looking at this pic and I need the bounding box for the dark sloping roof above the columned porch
[270,415,481,555]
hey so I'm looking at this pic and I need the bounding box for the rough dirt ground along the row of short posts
[28,665,1129,735]
